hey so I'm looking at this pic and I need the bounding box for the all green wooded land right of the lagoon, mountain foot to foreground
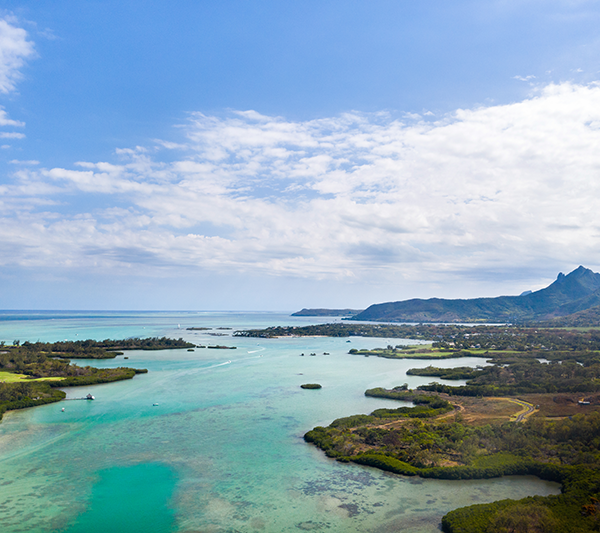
[296,324,600,533]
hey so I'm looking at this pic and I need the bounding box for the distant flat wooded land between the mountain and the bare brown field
[247,318,600,396]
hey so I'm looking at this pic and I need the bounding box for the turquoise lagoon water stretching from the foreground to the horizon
[0,313,558,533]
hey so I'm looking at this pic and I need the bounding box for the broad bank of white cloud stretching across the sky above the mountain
[0,83,600,294]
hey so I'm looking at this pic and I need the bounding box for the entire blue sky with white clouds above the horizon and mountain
[0,0,600,311]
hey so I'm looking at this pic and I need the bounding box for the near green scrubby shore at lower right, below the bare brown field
[305,396,600,533]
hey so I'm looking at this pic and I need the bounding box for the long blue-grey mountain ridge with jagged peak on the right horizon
[353,266,600,322]
